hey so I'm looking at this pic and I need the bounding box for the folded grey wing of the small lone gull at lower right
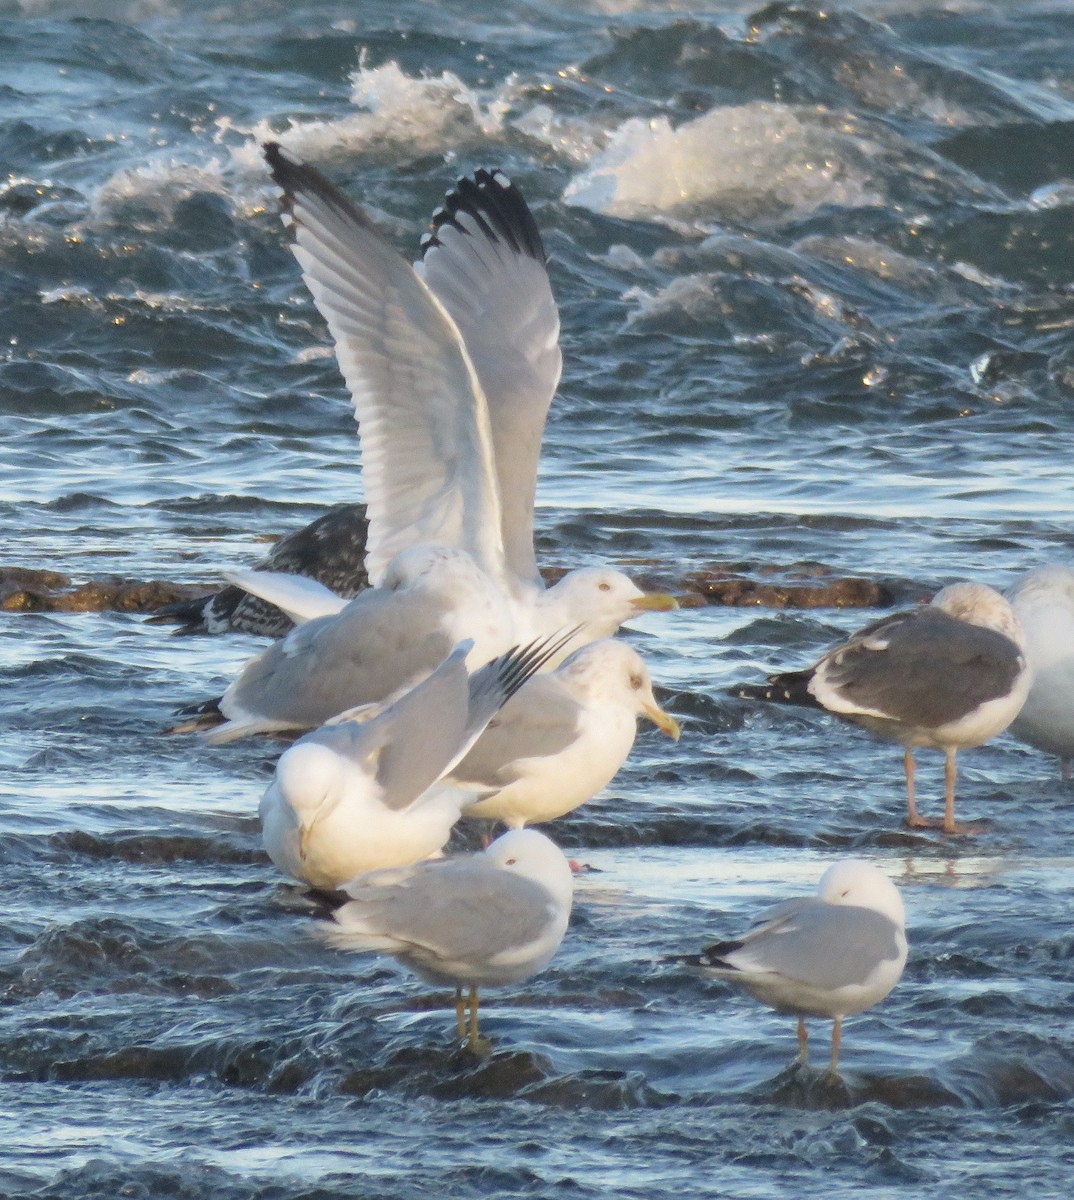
[722,896,900,988]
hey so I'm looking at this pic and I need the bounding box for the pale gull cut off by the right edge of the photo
[1007,565,1074,781]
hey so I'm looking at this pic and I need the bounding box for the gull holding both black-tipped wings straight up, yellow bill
[264,143,677,653]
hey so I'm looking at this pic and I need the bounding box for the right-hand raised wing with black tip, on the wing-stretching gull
[415,170,563,595]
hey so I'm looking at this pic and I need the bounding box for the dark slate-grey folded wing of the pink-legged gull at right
[812,607,1024,727]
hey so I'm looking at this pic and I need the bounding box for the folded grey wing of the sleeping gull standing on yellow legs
[332,854,554,961]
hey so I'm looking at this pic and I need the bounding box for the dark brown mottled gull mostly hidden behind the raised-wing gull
[149,504,370,637]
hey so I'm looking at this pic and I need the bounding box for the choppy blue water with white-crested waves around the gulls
[0,0,1074,1200]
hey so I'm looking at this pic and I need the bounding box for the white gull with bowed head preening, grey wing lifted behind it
[260,640,571,889]
